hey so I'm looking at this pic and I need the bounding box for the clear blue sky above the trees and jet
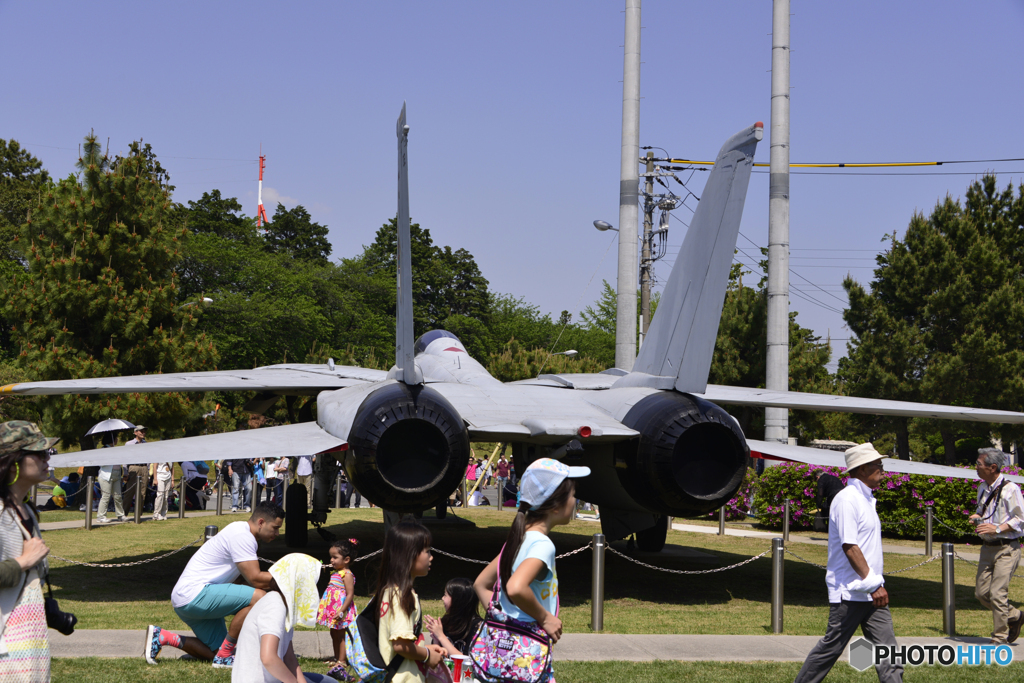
[0,0,1024,368]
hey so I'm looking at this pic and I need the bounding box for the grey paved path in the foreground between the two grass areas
[49,631,1018,661]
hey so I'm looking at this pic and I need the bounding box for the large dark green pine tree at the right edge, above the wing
[841,175,1024,465]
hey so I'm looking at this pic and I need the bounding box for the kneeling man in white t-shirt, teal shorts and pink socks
[145,503,285,669]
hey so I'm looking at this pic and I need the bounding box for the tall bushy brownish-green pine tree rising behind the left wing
[0,134,217,444]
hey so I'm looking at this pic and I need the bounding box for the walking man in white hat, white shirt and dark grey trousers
[796,443,903,683]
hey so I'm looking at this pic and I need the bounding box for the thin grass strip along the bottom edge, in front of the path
[52,657,1024,683]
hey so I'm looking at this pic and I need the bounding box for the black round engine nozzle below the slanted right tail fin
[615,391,751,517]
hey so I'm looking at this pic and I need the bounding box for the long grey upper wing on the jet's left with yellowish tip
[0,364,387,396]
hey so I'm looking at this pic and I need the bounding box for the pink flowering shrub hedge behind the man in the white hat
[753,463,1022,540]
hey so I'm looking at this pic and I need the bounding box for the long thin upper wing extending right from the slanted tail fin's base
[696,384,1024,424]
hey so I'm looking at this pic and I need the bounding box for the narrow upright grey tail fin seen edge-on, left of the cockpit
[394,102,423,384]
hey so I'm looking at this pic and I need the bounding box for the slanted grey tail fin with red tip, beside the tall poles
[620,122,764,393]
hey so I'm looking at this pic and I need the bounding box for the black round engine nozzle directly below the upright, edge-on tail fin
[337,382,470,512]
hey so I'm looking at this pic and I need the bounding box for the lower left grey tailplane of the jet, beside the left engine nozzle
[50,422,344,467]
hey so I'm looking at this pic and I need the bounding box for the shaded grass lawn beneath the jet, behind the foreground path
[39,509,1024,636]
